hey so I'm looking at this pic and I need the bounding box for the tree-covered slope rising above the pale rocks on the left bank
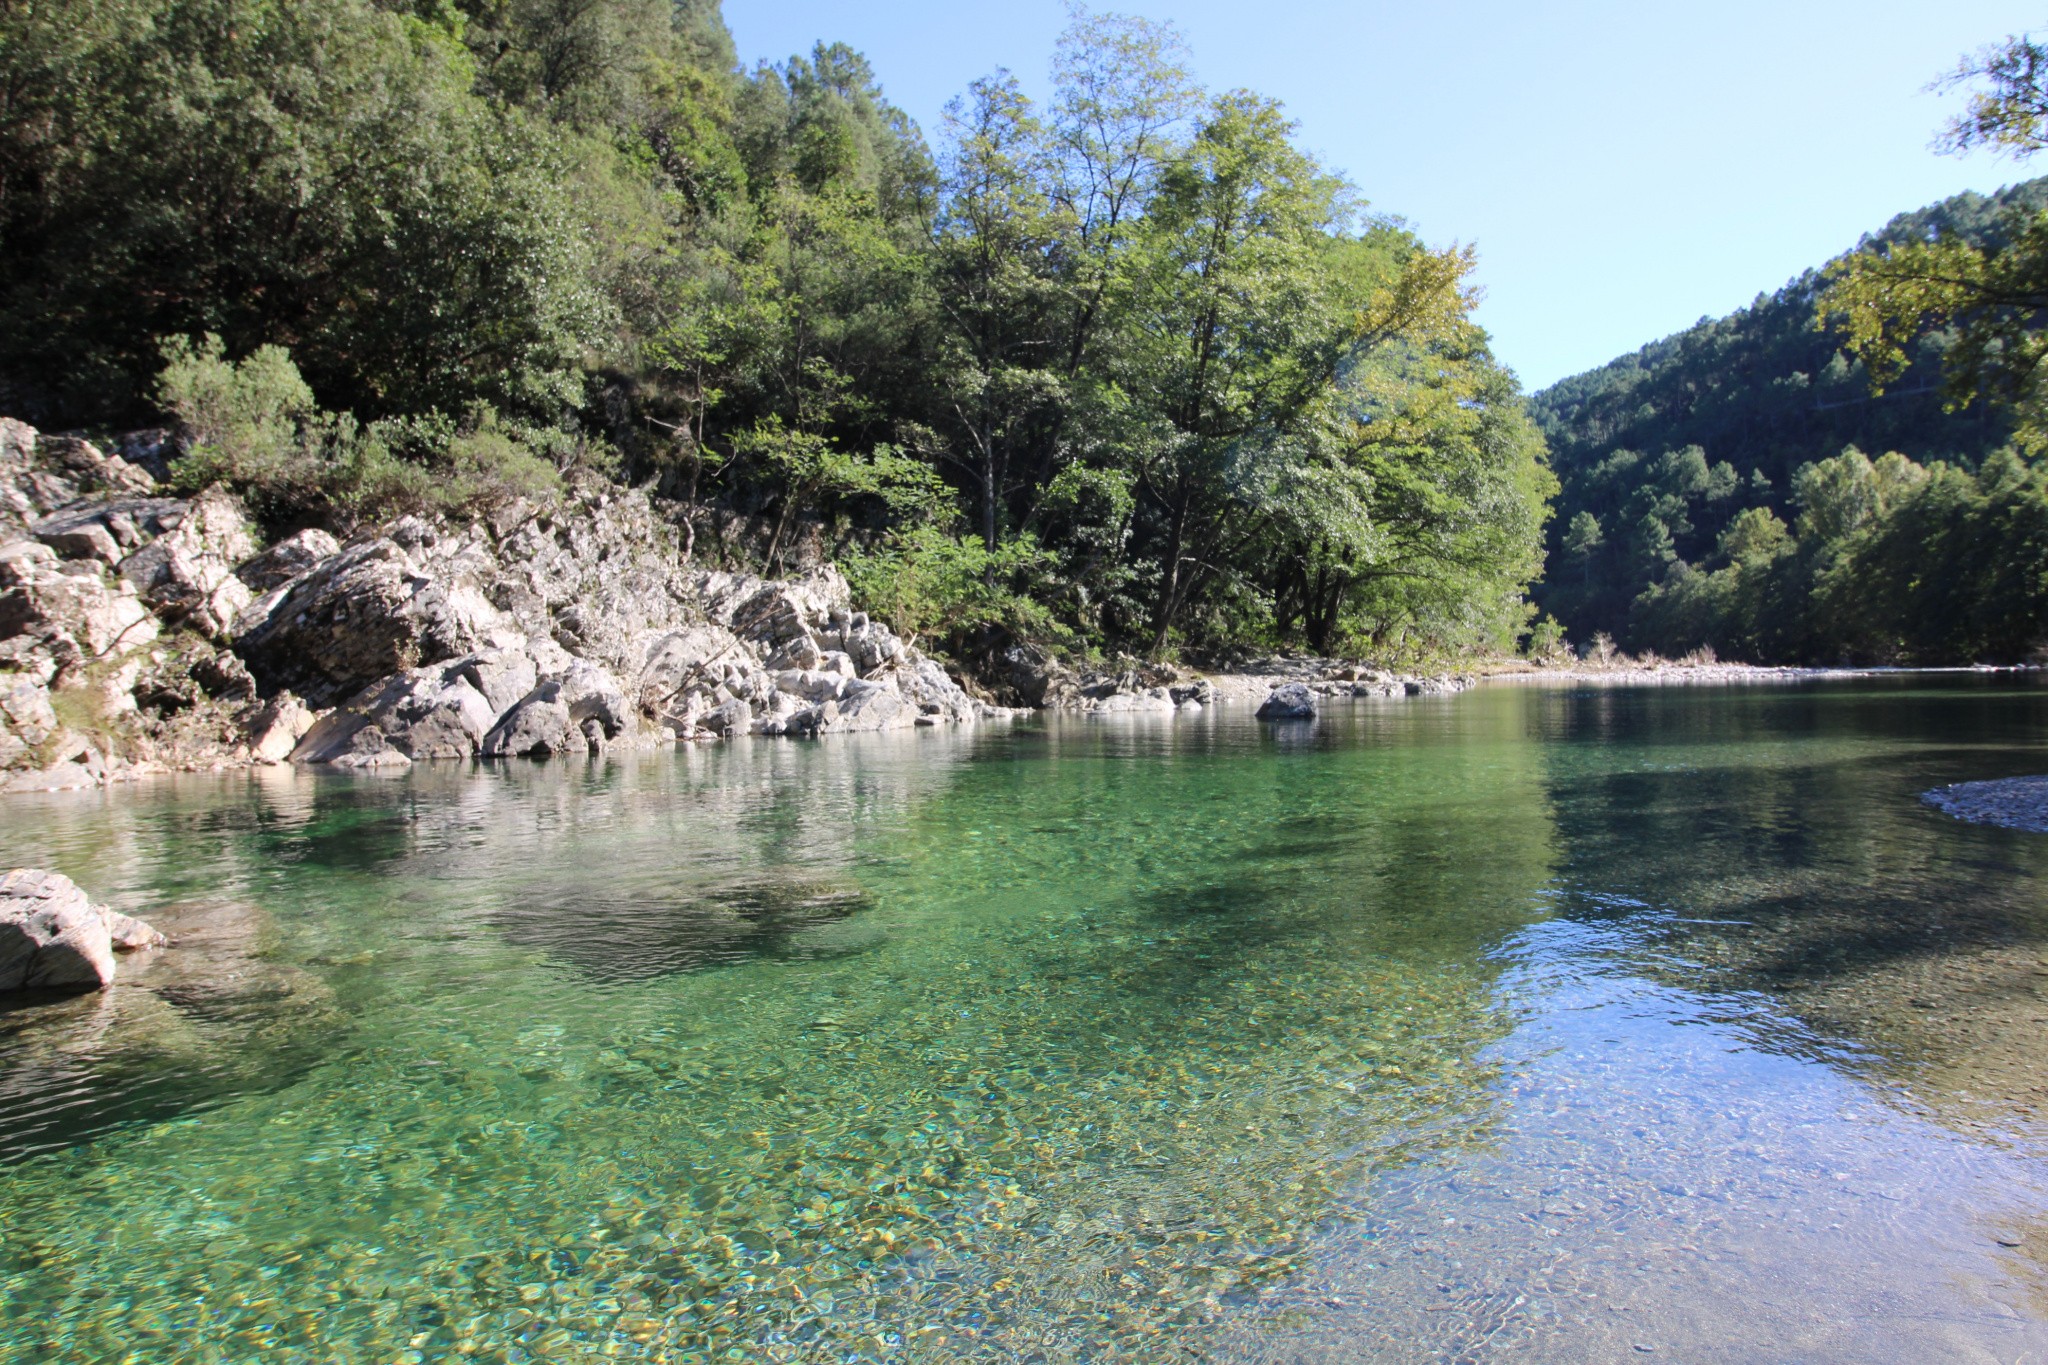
[0,0,1554,653]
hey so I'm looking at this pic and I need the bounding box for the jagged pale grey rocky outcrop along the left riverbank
[0,420,1008,790]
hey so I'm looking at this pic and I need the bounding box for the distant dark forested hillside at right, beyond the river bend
[1530,180,2048,663]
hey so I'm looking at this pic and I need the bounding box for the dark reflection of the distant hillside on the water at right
[1544,684,2048,1126]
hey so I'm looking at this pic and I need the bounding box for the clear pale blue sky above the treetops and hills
[725,0,2048,389]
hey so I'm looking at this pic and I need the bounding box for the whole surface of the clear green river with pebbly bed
[0,677,2048,1363]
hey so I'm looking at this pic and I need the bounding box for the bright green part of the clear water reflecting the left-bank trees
[0,712,1550,1361]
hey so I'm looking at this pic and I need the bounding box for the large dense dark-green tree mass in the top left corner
[0,0,608,422]
